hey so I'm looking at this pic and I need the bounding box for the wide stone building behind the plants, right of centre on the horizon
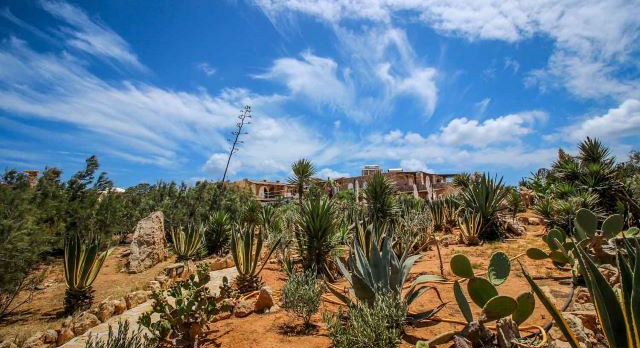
[334,165,455,200]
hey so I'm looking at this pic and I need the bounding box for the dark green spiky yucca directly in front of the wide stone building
[364,173,400,224]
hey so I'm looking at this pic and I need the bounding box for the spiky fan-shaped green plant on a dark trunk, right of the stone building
[460,174,509,240]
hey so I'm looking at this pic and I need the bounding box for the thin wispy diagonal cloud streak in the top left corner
[40,0,144,70]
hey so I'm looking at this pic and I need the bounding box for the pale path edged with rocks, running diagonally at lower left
[60,267,238,348]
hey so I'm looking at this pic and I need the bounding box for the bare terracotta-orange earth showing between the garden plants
[0,214,569,348]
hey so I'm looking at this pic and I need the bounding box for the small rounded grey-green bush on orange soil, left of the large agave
[282,270,323,328]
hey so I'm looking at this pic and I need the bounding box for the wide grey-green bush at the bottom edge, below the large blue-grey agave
[324,295,407,348]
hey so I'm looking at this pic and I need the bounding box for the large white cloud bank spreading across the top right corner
[254,0,640,100]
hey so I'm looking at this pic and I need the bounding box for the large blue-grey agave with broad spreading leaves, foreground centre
[329,236,445,320]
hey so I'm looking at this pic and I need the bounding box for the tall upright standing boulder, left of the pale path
[129,211,168,273]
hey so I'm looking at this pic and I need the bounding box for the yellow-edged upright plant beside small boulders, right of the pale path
[231,225,280,293]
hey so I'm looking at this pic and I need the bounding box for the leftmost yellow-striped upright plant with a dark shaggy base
[64,233,111,314]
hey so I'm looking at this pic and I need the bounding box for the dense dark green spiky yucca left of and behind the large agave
[295,197,340,279]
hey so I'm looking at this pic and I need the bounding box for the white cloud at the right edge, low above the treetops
[562,99,640,142]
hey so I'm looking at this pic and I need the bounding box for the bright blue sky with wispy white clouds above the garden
[0,0,640,186]
